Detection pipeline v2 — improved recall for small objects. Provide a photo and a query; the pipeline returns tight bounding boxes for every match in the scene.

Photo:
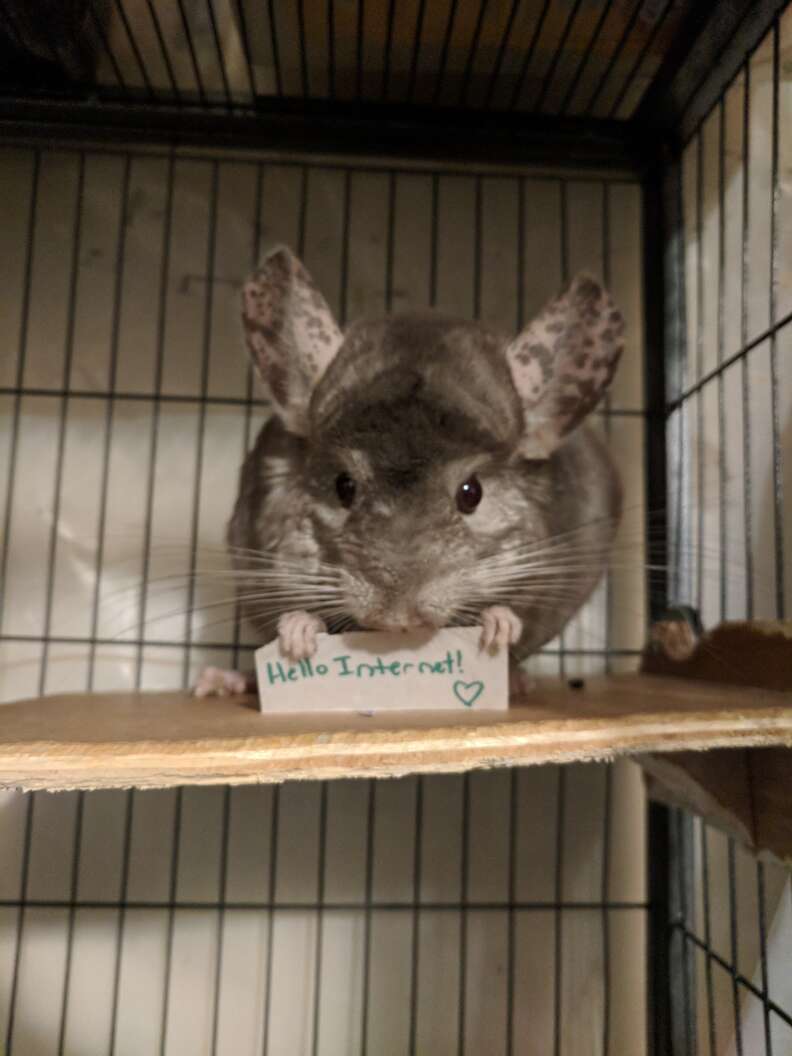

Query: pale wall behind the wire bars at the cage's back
[0,142,645,1056]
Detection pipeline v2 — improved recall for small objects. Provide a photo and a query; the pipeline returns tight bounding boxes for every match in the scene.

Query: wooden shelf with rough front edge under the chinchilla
[0,675,792,790]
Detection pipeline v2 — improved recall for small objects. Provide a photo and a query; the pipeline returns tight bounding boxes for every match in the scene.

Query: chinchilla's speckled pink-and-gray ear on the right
[506,275,624,458]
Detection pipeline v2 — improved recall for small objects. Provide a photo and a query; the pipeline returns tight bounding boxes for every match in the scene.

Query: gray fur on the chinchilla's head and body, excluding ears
[228,257,621,659]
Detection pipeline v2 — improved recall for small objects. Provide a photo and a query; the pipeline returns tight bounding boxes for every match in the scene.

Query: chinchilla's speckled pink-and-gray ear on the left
[242,246,342,435]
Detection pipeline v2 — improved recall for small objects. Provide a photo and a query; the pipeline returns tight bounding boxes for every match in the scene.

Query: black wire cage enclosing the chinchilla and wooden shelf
[0,0,792,1056]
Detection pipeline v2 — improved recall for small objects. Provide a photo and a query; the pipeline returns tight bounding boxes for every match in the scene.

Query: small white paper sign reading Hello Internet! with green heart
[256,627,509,713]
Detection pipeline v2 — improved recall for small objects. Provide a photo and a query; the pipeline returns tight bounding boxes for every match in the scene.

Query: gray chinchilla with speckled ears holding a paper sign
[197,242,624,693]
